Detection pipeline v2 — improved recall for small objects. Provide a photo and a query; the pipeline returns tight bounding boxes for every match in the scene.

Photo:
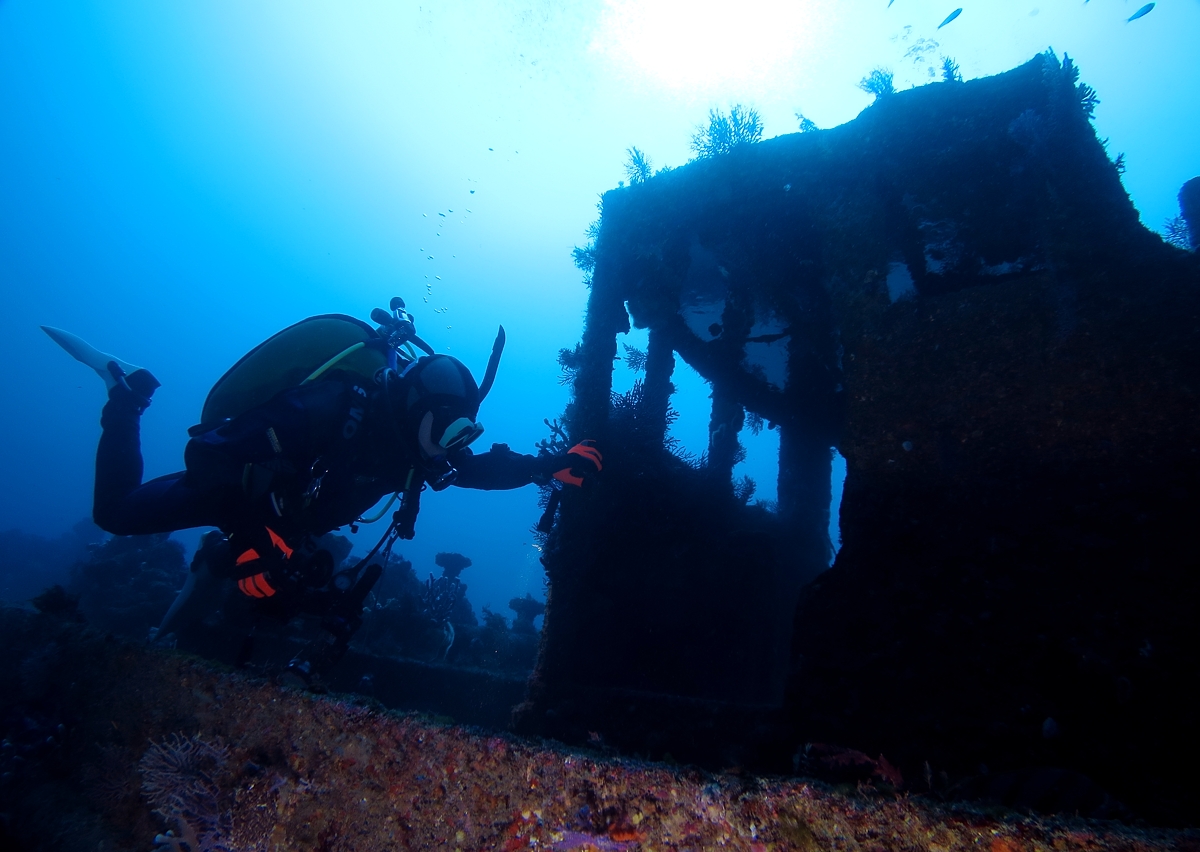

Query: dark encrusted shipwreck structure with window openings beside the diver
[525,54,1200,814]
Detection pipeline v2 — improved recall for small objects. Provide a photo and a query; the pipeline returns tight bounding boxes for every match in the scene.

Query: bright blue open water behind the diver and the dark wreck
[0,0,1200,612]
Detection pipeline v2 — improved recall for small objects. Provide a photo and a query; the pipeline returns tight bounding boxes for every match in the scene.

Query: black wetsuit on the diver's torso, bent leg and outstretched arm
[92,373,564,540]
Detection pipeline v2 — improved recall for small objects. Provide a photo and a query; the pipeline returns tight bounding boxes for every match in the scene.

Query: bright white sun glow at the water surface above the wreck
[590,0,816,96]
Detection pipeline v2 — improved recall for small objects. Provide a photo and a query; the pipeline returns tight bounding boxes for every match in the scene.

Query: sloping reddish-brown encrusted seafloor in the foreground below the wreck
[0,610,1200,852]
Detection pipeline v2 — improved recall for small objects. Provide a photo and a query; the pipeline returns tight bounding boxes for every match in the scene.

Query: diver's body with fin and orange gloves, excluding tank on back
[47,307,601,674]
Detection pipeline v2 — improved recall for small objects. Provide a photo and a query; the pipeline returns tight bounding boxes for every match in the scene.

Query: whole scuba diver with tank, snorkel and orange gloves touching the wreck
[42,296,602,684]
